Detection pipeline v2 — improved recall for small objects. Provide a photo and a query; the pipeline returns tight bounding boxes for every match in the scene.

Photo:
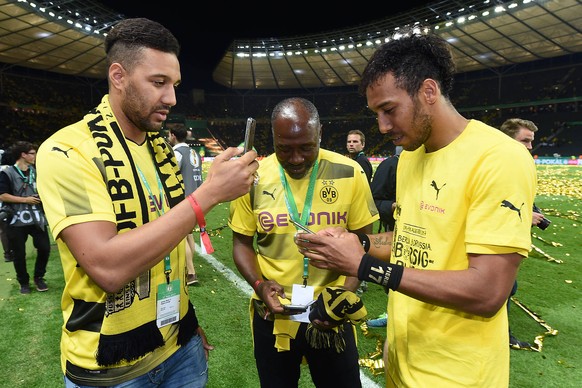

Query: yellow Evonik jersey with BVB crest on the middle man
[228,149,379,298]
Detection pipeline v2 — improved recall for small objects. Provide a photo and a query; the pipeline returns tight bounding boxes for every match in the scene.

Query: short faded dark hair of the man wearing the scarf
[105,18,180,68]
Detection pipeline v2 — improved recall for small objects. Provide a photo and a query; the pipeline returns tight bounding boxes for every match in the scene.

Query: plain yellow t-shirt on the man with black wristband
[386,121,536,388]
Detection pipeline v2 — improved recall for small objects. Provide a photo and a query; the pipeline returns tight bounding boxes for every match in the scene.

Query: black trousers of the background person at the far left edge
[8,225,51,285]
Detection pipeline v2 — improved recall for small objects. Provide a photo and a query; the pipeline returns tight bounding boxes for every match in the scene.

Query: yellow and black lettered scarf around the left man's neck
[84,95,198,366]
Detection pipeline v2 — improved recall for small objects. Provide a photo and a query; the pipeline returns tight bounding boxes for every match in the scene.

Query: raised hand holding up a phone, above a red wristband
[201,147,259,203]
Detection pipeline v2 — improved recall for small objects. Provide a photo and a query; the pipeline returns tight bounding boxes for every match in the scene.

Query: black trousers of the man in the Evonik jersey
[253,312,362,388]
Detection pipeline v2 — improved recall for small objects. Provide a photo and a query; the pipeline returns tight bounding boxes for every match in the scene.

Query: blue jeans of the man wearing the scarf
[64,335,208,388]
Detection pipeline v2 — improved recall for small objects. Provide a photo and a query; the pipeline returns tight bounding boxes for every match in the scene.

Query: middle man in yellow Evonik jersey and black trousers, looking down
[228,98,378,388]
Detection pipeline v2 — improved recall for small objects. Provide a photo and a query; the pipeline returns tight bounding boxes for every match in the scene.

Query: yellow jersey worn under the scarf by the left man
[37,121,189,385]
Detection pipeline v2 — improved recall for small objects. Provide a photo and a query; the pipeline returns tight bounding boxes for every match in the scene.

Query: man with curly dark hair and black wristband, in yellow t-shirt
[295,28,536,388]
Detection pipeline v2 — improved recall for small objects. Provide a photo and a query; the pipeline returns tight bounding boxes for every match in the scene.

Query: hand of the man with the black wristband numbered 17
[295,227,365,277]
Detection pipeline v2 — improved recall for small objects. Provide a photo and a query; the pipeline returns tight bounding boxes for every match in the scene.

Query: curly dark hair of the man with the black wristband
[359,31,456,99]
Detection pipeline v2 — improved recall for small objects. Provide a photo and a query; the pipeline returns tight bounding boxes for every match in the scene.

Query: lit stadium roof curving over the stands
[0,0,582,90]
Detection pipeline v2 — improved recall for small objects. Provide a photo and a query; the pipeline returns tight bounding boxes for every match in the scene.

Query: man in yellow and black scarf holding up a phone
[38,18,258,388]
